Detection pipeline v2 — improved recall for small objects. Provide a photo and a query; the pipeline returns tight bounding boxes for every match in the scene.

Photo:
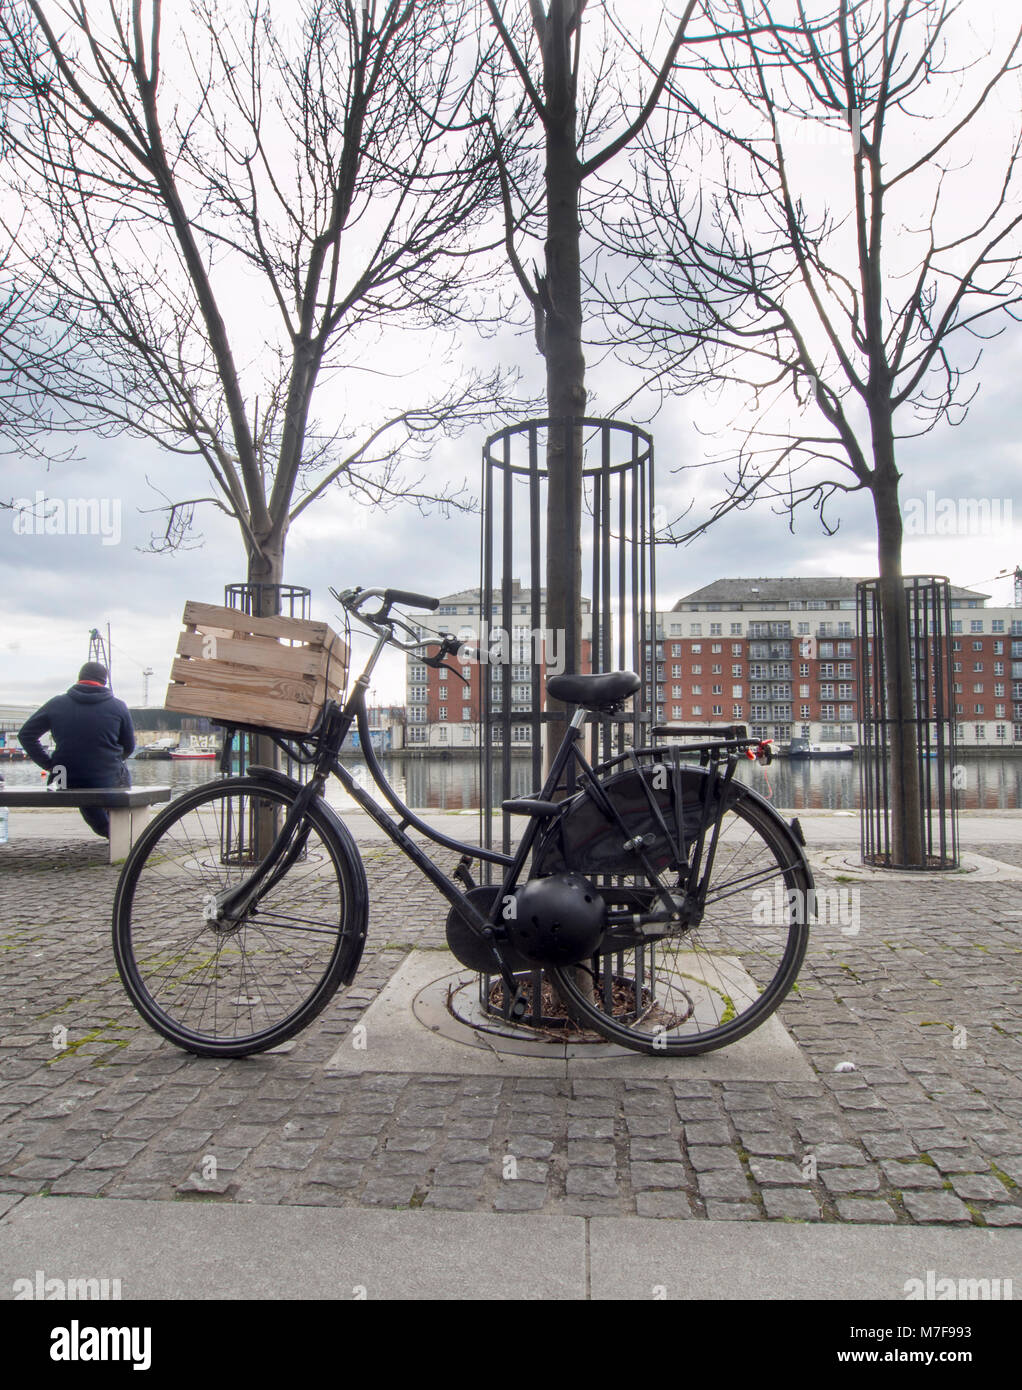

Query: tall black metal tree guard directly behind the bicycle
[480,417,656,1026]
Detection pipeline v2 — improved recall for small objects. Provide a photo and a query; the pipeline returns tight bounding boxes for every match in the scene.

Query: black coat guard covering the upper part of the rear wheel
[533,765,716,877]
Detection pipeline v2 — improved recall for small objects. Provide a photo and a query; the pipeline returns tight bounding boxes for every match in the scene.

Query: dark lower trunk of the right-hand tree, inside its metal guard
[873,453,925,867]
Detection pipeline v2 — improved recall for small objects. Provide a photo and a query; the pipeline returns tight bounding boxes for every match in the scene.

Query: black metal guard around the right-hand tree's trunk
[855,575,958,869]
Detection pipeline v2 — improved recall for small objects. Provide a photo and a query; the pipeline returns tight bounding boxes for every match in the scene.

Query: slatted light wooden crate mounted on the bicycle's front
[165,602,348,734]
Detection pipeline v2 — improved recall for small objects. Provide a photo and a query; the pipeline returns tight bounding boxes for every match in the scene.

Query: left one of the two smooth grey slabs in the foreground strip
[0,1197,585,1301]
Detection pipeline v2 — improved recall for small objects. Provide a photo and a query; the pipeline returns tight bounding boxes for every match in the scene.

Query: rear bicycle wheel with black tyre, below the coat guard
[551,769,812,1056]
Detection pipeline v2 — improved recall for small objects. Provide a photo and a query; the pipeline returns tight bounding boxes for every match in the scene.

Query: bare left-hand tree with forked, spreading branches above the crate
[0,0,520,608]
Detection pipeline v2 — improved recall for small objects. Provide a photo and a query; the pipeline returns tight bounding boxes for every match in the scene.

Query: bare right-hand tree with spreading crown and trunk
[605,0,1022,865]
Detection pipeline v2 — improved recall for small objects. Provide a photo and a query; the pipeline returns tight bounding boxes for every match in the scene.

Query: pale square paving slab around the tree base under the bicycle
[325,951,813,1081]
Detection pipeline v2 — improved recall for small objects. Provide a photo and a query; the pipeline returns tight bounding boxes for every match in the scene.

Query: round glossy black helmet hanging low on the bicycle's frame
[508,873,606,965]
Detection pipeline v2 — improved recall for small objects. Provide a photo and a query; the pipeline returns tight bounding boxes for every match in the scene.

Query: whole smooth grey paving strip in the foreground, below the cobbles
[0,1197,1022,1302]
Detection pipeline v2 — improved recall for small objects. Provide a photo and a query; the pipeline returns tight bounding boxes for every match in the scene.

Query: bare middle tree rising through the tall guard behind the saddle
[487,0,697,695]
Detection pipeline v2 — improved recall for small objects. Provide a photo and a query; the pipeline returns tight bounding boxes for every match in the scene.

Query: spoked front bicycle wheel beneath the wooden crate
[114,777,367,1056]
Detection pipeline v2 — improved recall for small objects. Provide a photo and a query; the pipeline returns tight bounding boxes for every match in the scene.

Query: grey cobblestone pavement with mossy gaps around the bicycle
[0,840,1022,1226]
